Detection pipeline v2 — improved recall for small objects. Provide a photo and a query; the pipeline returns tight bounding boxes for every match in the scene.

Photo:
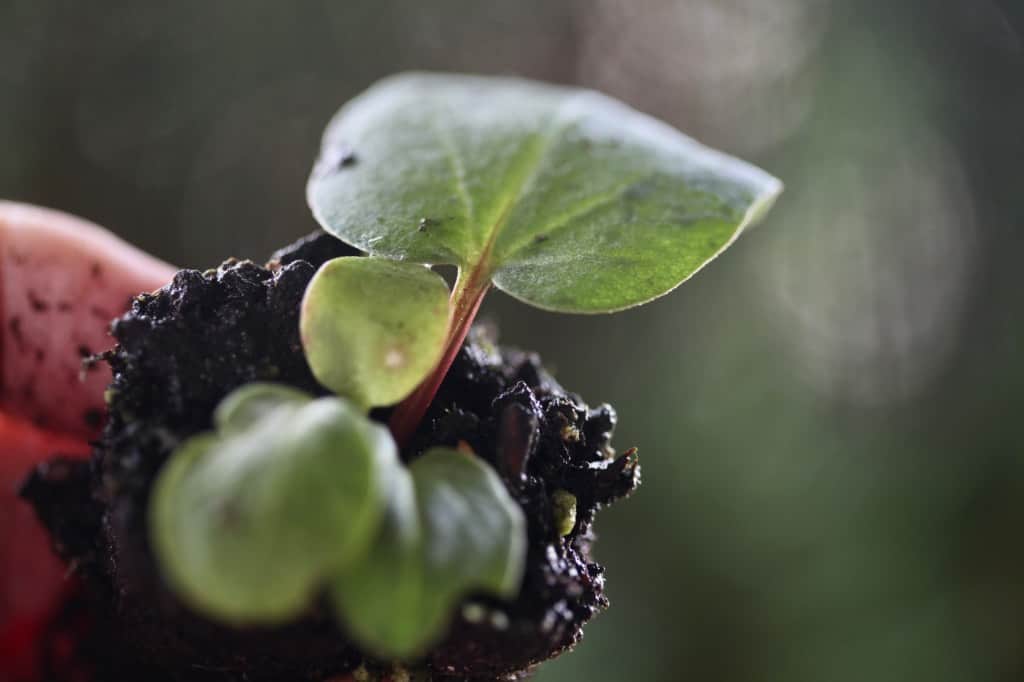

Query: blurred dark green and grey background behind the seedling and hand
[0,0,1024,682]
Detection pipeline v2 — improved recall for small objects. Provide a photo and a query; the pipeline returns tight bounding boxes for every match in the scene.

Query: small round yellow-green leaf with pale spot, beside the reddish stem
[300,253,450,408]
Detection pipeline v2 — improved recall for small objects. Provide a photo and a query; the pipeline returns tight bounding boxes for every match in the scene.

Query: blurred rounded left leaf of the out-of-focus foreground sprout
[150,384,401,624]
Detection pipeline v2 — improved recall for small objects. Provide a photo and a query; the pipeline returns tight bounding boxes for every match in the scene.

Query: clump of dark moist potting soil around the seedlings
[24,229,639,682]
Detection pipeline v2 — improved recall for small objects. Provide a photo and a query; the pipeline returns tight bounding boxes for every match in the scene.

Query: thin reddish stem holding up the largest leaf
[389,268,490,449]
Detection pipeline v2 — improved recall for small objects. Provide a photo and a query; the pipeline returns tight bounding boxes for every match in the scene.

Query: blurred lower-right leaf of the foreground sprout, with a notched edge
[333,447,526,658]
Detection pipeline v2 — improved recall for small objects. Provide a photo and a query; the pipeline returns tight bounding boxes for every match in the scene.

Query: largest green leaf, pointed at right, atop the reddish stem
[307,74,781,312]
